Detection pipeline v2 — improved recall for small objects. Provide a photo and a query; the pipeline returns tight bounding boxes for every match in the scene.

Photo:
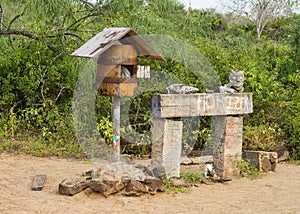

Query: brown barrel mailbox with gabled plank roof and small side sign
[72,28,165,97]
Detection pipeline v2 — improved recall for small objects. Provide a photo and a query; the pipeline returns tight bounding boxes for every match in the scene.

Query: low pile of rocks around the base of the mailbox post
[58,162,166,197]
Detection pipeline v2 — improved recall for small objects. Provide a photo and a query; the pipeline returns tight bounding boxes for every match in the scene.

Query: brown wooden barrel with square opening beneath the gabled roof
[97,45,138,96]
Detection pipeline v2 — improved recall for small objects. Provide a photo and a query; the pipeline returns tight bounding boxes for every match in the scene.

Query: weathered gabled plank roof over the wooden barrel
[71,28,165,61]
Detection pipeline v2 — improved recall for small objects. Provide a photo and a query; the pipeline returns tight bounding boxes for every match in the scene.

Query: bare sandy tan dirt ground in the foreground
[0,153,300,214]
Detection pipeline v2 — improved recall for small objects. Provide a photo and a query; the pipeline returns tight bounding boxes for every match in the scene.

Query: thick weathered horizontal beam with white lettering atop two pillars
[152,93,253,118]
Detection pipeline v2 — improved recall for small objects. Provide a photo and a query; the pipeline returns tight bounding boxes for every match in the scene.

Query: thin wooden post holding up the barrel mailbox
[112,95,121,162]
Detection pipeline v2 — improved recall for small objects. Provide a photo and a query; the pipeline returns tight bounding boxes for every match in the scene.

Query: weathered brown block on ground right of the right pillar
[243,151,278,172]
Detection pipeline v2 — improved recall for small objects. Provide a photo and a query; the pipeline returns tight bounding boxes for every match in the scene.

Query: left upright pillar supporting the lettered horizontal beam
[151,118,183,178]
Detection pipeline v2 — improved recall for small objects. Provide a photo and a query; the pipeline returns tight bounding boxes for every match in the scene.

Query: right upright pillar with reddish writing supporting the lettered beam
[214,116,243,178]
